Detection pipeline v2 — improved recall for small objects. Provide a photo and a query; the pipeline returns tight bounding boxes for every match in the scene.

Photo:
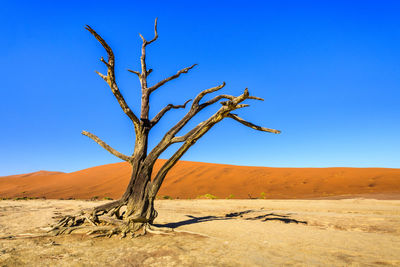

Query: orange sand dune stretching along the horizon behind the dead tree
[0,160,400,199]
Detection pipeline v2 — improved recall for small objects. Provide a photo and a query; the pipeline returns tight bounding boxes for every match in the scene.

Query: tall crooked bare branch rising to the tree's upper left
[85,25,140,132]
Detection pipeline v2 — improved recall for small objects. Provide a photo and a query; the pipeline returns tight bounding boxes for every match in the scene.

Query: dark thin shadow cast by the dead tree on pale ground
[155,210,307,228]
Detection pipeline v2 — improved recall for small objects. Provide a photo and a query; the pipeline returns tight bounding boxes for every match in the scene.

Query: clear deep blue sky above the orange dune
[0,0,400,175]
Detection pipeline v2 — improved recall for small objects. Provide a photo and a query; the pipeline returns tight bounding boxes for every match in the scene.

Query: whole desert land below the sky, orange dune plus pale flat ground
[0,160,400,266]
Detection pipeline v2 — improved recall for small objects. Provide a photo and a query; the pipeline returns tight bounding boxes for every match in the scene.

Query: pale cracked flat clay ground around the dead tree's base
[0,199,400,266]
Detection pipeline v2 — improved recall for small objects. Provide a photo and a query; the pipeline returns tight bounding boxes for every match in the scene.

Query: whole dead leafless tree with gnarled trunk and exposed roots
[52,19,280,239]
